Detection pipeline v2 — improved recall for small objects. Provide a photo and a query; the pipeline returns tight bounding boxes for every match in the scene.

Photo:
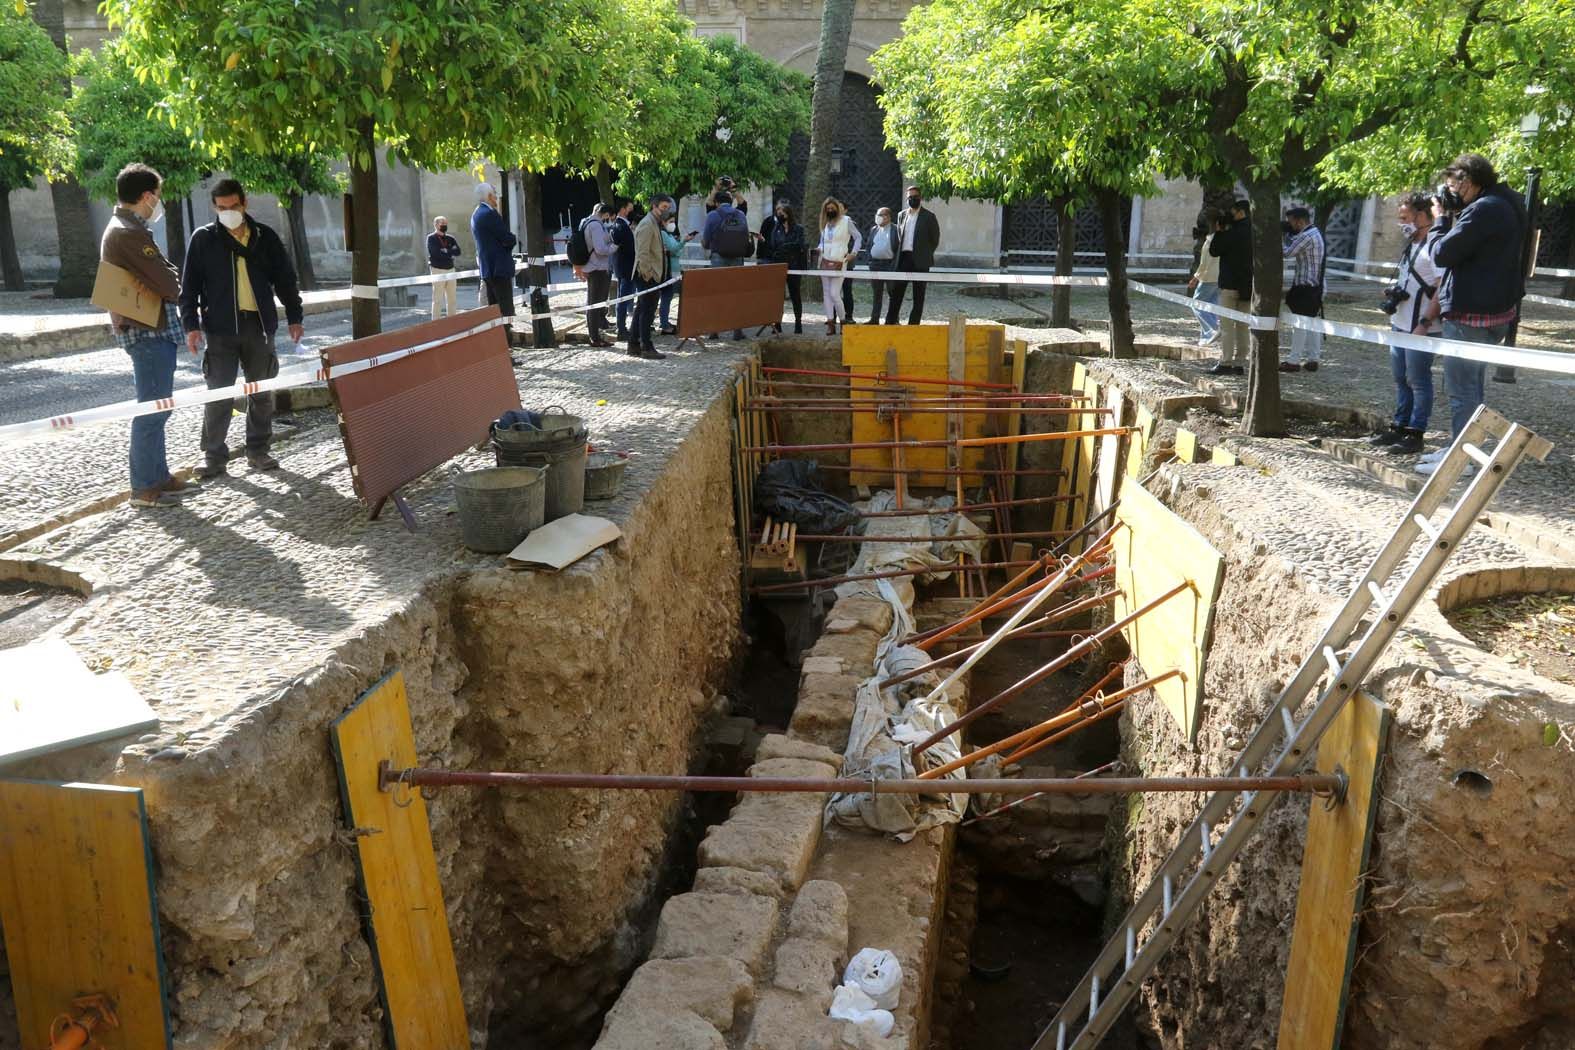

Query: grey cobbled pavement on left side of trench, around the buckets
[8,342,742,732]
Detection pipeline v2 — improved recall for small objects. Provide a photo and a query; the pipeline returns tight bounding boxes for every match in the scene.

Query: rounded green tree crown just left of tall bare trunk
[617,36,810,198]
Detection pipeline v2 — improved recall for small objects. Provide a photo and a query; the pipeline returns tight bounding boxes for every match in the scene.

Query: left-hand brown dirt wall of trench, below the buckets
[0,390,739,1050]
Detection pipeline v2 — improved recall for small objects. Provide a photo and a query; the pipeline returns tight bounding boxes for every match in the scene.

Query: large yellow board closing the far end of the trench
[843,324,1005,488]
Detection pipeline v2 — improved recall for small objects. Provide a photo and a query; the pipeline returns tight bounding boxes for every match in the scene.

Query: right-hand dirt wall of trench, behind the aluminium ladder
[1107,485,1575,1050]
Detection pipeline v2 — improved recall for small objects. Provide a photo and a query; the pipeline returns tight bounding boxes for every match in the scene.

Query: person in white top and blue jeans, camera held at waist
[1369,194,1440,455]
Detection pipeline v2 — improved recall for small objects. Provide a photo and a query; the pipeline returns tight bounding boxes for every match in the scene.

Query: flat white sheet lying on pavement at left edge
[0,638,159,765]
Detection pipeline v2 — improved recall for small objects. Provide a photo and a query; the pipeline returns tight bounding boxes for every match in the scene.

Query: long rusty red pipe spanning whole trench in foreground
[378,763,1345,795]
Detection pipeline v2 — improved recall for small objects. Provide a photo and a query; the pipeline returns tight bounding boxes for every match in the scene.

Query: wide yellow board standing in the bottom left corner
[0,781,170,1050]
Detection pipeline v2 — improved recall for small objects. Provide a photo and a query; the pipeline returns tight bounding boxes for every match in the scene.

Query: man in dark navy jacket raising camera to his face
[1418,153,1526,459]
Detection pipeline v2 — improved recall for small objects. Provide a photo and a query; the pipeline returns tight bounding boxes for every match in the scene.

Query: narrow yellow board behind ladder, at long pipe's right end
[1279,693,1389,1050]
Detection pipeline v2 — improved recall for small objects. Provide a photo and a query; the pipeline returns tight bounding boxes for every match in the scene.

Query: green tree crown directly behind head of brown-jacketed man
[71,41,213,200]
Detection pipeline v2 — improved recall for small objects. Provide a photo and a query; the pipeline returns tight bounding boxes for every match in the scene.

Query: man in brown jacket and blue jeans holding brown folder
[99,164,186,507]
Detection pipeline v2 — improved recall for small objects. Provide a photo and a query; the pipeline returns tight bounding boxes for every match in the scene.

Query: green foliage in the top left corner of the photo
[0,6,71,181]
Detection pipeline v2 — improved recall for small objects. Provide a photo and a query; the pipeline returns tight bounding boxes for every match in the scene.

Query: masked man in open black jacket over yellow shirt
[181,178,306,479]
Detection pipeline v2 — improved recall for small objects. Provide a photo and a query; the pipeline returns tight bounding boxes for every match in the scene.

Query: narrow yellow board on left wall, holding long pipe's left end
[332,671,471,1050]
